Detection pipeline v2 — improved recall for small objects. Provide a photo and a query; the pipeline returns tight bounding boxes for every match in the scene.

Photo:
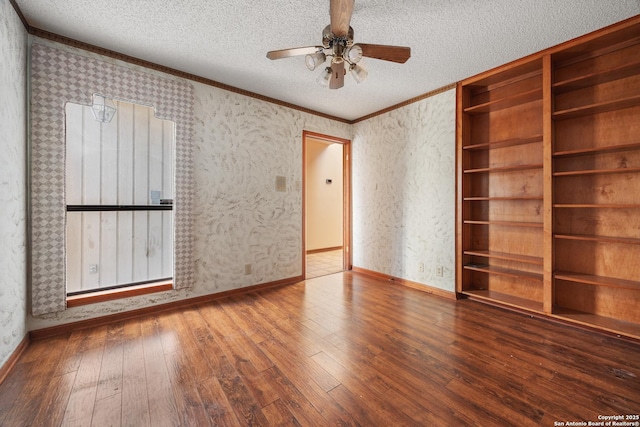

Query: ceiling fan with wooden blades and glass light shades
[267,0,411,89]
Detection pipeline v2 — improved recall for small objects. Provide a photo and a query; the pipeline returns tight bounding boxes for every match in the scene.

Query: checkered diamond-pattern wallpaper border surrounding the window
[30,43,195,316]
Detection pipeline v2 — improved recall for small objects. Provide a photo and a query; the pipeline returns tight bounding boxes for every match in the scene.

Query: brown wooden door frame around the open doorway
[302,130,353,279]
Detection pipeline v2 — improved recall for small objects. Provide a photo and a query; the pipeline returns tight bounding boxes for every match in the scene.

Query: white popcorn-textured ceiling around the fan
[16,0,640,120]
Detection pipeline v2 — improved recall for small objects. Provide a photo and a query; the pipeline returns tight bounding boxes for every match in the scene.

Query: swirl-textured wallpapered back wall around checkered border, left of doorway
[29,40,351,330]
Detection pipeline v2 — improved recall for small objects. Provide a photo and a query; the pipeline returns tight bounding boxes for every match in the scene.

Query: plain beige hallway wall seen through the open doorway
[305,138,343,251]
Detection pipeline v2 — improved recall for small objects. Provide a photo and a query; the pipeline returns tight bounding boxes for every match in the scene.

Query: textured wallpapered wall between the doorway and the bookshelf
[352,89,455,292]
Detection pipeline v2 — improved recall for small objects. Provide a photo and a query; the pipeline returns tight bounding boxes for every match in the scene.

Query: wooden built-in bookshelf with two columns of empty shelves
[456,16,640,339]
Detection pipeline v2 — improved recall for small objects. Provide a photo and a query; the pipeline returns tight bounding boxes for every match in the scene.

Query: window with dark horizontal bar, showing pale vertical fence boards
[65,101,175,295]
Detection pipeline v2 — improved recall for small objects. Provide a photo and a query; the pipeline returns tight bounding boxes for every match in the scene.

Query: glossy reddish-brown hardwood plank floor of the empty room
[0,273,640,427]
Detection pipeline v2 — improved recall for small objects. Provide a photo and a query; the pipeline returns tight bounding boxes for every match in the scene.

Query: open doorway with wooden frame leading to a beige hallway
[302,131,351,279]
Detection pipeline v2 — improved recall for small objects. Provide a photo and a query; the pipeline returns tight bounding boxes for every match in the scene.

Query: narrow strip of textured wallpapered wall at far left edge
[0,0,27,366]
